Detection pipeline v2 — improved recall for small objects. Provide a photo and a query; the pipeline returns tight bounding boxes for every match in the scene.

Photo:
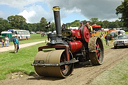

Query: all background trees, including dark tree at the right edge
[0,0,128,33]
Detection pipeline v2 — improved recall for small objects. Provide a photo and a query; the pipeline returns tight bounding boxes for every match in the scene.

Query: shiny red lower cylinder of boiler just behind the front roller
[69,41,83,53]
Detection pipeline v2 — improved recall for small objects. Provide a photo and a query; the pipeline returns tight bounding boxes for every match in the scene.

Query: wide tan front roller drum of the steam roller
[34,50,73,78]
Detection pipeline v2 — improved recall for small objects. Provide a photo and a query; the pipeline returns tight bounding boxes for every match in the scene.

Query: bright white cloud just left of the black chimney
[19,5,53,23]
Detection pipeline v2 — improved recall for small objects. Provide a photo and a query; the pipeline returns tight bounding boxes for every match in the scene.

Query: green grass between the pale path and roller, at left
[0,43,45,80]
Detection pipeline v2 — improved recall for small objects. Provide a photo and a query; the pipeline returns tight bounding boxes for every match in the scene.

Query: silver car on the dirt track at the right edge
[114,35,128,49]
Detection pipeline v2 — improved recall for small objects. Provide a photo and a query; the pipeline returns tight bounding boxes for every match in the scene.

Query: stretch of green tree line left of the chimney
[0,15,53,32]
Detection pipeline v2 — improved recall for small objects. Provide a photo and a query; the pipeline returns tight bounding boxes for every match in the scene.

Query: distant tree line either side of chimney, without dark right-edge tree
[0,15,123,32]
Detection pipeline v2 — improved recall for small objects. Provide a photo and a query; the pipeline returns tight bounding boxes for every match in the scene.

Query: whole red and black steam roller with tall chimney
[32,6,104,78]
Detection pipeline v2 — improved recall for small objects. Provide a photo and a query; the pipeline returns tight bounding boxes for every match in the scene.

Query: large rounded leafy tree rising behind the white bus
[8,15,26,29]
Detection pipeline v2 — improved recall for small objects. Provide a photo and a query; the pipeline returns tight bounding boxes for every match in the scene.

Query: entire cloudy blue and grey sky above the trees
[0,0,123,24]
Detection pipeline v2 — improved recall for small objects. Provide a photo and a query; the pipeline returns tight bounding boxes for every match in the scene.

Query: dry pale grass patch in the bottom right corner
[92,58,128,85]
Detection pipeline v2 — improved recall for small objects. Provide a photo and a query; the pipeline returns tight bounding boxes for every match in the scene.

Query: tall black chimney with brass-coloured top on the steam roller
[53,6,62,37]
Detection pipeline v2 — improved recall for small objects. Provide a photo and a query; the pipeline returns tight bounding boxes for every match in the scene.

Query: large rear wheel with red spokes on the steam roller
[88,37,104,65]
